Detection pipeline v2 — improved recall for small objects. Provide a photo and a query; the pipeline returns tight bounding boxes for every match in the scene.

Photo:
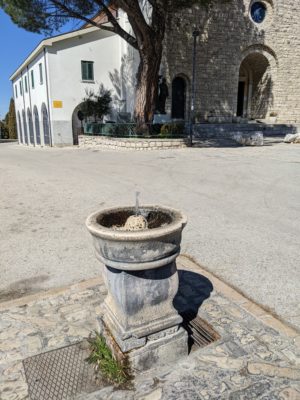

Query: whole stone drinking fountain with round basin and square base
[86,206,188,371]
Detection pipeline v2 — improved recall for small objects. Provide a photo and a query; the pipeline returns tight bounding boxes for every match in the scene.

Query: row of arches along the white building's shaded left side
[17,103,51,146]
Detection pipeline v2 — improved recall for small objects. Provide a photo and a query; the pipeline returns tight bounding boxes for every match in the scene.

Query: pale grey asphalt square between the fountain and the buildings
[0,143,300,327]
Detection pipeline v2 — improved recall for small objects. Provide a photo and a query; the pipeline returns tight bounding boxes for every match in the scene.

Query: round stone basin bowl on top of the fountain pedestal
[86,206,187,271]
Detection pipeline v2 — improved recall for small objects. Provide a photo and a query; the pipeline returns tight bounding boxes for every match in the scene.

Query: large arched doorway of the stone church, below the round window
[236,52,273,119]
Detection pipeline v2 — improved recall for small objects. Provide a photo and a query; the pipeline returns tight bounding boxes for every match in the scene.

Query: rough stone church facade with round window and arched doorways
[162,0,300,124]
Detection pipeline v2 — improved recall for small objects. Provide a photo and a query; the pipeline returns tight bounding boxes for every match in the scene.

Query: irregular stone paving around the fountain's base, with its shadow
[0,257,300,400]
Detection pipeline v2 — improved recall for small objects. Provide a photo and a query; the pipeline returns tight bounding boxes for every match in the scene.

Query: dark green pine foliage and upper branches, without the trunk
[0,0,211,39]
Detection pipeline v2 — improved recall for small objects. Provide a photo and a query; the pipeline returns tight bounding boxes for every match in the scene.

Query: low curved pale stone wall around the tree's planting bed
[79,135,188,150]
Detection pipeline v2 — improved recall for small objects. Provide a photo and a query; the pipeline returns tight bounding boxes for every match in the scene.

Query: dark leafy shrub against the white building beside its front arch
[80,85,112,121]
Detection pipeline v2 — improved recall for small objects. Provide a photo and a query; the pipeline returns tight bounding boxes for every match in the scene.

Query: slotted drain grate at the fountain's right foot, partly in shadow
[182,312,220,351]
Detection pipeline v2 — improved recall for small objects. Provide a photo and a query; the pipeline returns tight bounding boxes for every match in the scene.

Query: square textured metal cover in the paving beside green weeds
[23,341,104,400]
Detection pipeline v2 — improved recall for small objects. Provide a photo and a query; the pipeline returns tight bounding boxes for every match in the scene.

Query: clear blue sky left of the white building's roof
[0,9,79,119]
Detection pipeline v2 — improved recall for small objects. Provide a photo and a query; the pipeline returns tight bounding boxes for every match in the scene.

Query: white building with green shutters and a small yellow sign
[10,19,135,146]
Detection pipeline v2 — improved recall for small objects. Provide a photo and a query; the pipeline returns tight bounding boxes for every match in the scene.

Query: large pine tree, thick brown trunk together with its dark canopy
[0,0,216,123]
